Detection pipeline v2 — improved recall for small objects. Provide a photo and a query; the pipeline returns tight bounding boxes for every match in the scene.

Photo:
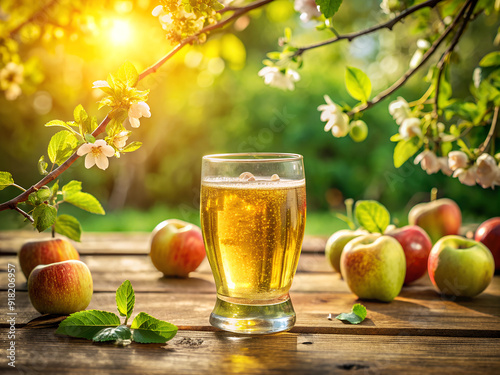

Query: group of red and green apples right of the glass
[325,199,500,302]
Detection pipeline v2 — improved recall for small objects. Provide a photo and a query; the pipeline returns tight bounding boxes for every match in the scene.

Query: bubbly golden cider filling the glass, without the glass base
[201,177,306,301]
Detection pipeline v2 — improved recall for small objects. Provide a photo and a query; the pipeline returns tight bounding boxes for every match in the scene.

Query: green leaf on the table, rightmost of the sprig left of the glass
[131,312,177,344]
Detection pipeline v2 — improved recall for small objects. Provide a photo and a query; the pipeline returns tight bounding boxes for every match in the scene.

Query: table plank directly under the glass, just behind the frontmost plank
[0,290,500,337]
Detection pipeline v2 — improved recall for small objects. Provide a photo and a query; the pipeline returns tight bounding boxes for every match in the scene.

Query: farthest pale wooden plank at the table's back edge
[0,230,326,255]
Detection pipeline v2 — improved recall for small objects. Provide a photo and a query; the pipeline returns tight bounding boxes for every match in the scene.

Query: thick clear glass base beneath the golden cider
[210,295,295,334]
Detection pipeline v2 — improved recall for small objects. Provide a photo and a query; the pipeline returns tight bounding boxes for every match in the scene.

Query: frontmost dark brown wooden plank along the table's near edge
[0,328,500,375]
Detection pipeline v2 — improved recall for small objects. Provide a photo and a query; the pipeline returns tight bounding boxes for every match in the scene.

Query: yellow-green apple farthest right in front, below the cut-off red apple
[427,236,495,297]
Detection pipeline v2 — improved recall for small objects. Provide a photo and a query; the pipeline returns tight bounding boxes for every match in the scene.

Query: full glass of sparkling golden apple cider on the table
[200,153,306,334]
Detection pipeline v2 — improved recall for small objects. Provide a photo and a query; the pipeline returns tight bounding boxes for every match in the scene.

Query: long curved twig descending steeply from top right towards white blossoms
[347,0,477,116]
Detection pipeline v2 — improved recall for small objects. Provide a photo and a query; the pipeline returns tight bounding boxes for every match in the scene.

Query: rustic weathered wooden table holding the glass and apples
[0,231,500,374]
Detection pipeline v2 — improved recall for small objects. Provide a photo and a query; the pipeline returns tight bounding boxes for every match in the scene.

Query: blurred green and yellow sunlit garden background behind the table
[0,0,500,235]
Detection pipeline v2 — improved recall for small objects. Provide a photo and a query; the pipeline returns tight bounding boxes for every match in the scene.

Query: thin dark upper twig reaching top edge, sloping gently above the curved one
[292,0,443,57]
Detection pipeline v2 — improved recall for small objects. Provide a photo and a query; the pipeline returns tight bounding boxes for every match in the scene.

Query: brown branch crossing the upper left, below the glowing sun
[0,0,273,211]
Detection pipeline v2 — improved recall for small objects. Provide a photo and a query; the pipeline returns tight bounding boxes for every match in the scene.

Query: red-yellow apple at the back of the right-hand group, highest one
[408,198,462,243]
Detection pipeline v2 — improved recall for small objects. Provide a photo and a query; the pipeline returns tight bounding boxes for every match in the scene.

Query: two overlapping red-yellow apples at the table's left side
[19,238,93,315]
